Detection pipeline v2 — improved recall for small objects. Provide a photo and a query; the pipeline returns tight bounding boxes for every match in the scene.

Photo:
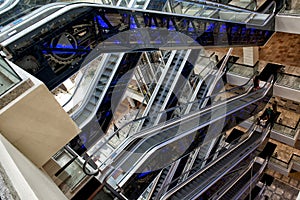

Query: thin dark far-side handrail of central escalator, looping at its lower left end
[83,72,254,175]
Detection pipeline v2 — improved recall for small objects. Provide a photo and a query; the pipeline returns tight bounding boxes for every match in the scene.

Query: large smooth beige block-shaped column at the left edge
[0,84,80,167]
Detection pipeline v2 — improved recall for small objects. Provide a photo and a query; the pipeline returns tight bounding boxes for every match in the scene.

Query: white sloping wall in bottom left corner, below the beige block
[0,134,67,200]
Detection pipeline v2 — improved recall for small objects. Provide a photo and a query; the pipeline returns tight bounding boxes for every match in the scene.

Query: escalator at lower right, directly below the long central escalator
[162,126,268,199]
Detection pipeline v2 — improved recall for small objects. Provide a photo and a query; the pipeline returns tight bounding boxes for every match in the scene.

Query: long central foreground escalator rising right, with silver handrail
[98,74,272,199]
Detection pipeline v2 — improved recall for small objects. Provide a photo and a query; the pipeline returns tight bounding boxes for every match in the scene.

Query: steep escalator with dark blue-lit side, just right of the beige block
[69,52,142,155]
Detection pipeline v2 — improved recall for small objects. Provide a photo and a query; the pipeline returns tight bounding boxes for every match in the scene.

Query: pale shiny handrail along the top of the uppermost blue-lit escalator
[2,2,274,46]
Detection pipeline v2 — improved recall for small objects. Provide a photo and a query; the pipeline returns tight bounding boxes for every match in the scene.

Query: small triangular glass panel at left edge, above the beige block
[0,56,21,94]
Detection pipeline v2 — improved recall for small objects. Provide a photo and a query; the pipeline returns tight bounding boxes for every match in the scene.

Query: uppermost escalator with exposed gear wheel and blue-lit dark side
[1,3,274,89]
